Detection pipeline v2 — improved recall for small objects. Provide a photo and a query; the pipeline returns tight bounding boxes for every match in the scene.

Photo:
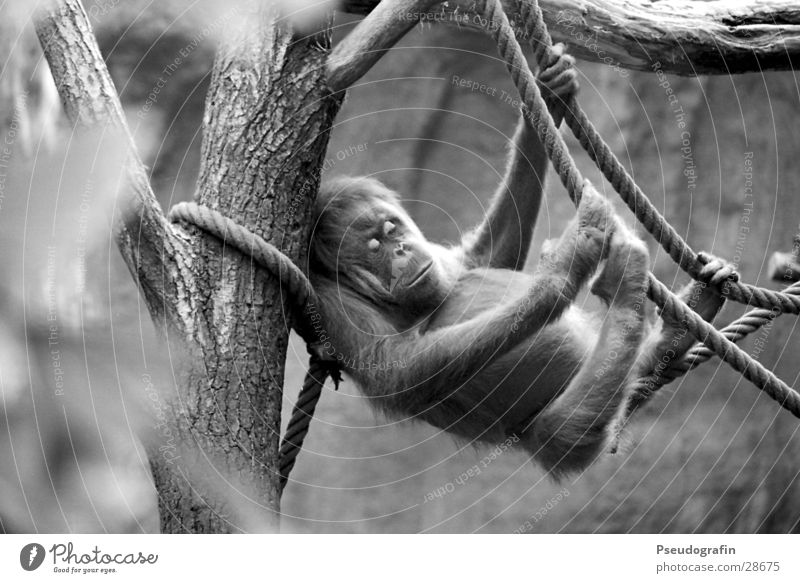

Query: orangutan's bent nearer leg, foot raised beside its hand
[521,228,649,477]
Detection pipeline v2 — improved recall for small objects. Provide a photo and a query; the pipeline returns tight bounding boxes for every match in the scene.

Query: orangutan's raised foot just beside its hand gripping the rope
[591,221,650,307]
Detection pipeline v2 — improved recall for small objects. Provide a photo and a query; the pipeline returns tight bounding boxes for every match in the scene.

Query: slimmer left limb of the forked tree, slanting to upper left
[34,0,175,325]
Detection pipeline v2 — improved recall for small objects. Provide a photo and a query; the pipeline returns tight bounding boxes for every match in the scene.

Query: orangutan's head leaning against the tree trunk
[311,178,448,320]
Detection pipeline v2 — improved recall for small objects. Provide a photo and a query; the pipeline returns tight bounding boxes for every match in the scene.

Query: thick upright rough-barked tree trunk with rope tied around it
[148,7,338,532]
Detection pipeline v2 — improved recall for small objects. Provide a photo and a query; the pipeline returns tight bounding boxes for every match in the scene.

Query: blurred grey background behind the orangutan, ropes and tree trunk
[0,0,800,533]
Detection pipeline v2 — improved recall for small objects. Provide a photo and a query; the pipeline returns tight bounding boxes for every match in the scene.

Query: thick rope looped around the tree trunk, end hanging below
[169,202,340,494]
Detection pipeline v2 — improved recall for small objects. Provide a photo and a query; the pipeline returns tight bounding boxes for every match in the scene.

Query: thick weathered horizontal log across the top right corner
[343,0,800,76]
